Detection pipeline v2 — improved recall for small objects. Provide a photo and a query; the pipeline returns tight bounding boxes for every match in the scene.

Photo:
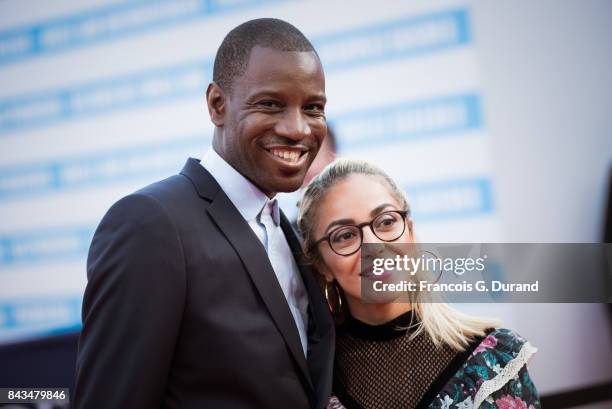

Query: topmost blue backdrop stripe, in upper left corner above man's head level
[0,0,279,64]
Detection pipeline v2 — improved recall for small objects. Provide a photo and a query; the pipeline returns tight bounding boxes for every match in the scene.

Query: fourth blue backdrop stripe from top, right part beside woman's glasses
[0,177,494,268]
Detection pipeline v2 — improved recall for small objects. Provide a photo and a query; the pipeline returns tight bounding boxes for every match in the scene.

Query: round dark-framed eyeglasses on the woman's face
[313,210,409,256]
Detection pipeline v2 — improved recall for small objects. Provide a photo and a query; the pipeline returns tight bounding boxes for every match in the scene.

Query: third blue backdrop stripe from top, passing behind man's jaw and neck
[0,94,482,202]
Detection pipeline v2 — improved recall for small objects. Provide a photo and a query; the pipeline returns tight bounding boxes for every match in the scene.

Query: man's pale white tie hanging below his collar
[260,199,308,355]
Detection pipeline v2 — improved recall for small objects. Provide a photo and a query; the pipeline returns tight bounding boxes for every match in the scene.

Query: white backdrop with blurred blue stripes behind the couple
[0,0,502,342]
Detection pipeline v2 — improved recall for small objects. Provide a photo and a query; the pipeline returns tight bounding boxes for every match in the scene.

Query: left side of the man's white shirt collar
[200,147,268,221]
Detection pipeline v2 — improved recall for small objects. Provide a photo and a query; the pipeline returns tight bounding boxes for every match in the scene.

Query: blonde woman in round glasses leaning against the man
[298,159,540,409]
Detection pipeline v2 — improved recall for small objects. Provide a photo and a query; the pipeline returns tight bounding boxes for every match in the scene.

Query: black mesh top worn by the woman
[334,312,480,409]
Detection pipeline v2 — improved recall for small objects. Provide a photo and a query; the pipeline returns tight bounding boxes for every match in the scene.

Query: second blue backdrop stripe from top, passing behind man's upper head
[0,10,470,134]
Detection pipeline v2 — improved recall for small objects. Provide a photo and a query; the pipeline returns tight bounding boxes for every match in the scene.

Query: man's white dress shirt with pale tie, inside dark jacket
[201,148,308,355]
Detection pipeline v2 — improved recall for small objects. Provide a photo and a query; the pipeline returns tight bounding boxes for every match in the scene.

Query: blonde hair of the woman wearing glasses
[298,159,500,351]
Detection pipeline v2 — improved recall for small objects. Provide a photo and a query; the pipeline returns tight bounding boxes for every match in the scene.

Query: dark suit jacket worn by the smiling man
[73,159,334,409]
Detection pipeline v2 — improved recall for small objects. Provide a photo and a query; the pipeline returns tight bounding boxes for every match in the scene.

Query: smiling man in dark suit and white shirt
[73,19,334,409]
